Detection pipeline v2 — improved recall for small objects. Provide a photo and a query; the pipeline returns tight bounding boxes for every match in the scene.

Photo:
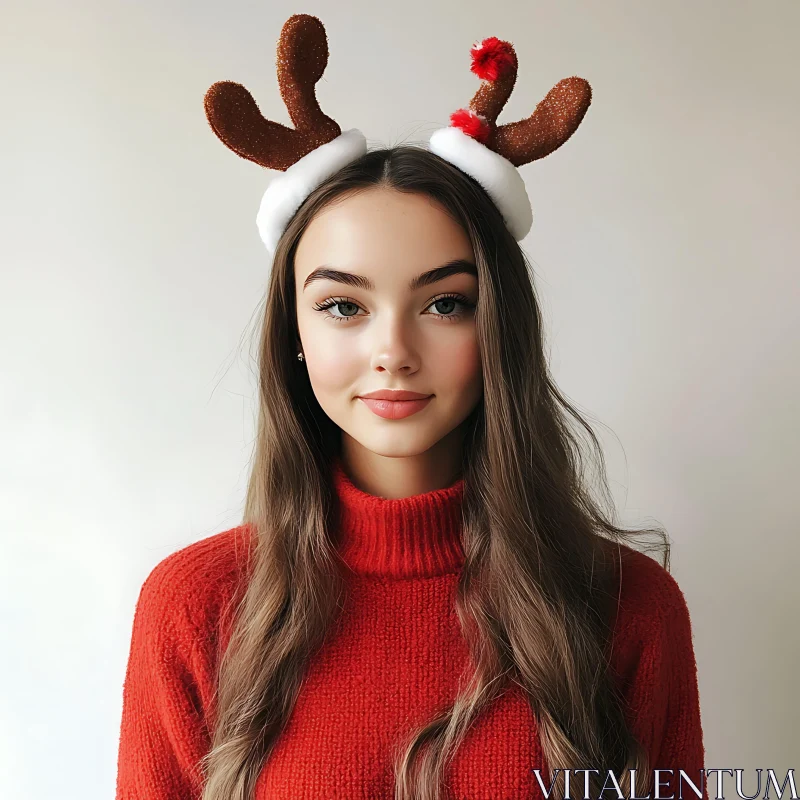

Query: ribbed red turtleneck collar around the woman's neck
[331,457,464,578]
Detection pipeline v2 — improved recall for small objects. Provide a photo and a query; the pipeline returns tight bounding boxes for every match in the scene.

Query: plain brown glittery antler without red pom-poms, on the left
[203,14,342,171]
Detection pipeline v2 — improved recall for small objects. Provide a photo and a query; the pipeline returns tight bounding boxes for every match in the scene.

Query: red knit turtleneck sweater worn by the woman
[116,462,707,800]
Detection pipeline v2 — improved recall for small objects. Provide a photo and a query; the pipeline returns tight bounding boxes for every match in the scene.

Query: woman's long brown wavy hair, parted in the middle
[197,145,669,800]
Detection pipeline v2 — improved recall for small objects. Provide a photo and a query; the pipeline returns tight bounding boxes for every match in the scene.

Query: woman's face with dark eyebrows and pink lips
[294,188,483,457]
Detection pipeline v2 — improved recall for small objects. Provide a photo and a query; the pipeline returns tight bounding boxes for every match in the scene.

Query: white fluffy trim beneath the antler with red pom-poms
[429,126,533,242]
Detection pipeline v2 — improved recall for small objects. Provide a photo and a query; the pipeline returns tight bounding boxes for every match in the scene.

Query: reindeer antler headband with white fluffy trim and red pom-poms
[204,14,592,253]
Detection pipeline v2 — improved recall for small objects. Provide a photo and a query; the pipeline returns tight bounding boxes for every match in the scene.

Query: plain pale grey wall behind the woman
[0,0,800,800]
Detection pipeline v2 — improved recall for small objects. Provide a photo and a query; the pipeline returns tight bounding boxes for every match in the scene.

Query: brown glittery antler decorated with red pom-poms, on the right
[456,37,592,167]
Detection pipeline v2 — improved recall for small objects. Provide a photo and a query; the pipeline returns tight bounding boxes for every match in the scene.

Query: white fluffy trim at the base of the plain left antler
[256,128,367,253]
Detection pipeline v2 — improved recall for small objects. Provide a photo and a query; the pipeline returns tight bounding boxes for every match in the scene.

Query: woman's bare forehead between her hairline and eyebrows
[295,187,474,283]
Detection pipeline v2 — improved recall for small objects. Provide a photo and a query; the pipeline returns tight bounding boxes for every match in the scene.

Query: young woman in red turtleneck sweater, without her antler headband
[117,12,705,800]
